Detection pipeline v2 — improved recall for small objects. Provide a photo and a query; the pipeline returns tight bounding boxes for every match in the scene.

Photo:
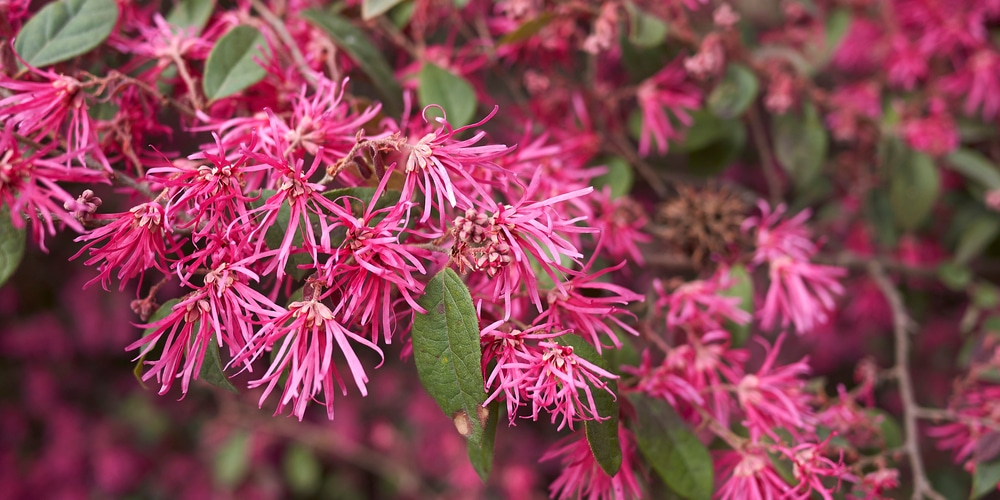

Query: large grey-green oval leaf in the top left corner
[14,0,118,67]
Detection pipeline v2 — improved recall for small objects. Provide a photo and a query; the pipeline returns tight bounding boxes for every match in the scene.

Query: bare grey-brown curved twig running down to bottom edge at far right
[868,261,944,500]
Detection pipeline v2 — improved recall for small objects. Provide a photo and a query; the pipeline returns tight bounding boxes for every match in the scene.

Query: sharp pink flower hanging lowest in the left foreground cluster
[240,292,384,420]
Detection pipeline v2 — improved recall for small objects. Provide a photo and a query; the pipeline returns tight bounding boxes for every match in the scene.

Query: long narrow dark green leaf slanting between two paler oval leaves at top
[302,10,403,116]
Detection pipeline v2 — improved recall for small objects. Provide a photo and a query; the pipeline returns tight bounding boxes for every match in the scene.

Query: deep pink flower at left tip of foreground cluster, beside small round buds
[71,203,180,290]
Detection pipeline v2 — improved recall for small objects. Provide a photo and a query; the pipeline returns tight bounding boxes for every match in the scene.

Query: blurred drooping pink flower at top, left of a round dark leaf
[636,58,701,156]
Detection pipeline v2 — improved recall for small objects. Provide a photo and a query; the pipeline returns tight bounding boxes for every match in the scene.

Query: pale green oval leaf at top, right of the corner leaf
[201,26,267,100]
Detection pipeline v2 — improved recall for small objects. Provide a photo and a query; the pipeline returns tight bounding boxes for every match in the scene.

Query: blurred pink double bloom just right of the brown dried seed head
[743,201,846,334]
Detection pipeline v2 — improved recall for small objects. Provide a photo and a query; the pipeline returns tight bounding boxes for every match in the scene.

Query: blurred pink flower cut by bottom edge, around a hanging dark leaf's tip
[539,426,642,500]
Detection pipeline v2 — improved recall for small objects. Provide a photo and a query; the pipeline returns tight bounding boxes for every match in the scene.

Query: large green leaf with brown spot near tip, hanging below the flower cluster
[412,268,486,446]
